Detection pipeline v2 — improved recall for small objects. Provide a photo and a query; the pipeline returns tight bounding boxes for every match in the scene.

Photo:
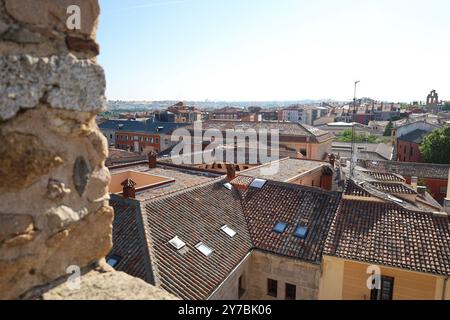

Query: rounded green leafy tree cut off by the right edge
[420,126,450,164]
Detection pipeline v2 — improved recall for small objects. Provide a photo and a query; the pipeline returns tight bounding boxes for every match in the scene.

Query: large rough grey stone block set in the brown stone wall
[0,54,106,120]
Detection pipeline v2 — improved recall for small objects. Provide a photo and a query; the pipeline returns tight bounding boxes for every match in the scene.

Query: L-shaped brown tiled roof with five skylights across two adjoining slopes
[111,177,340,299]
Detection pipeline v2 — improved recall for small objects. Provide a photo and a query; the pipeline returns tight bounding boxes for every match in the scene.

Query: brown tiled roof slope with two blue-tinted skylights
[242,181,341,263]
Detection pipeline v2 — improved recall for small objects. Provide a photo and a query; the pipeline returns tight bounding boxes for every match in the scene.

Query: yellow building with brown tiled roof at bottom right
[319,199,450,300]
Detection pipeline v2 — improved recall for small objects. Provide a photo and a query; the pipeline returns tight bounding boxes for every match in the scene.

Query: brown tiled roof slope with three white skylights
[143,182,252,299]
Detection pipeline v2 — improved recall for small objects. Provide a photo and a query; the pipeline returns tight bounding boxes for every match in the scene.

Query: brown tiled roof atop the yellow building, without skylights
[324,200,450,276]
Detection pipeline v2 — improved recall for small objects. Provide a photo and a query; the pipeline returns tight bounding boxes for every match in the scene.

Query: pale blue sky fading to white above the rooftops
[97,0,450,101]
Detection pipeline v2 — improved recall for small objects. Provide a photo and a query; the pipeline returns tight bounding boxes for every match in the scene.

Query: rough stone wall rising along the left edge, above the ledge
[0,0,176,299]
